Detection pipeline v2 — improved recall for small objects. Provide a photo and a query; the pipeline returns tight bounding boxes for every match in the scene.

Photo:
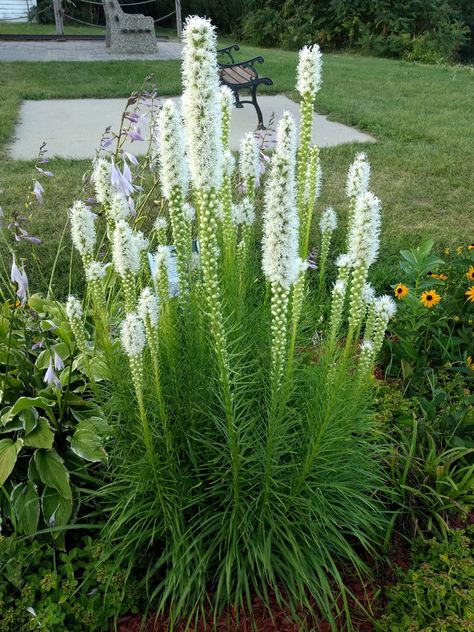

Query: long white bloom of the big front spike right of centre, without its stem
[262,126,301,289]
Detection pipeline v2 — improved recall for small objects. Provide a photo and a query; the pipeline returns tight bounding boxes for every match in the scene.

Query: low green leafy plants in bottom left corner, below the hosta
[0,536,140,632]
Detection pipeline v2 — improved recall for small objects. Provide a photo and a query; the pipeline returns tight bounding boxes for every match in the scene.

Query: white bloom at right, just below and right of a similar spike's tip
[348,191,380,268]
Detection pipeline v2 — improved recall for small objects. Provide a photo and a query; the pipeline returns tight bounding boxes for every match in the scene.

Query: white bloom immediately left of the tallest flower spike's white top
[157,99,189,199]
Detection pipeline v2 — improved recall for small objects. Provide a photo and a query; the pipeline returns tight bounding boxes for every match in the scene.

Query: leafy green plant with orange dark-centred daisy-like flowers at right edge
[387,241,474,392]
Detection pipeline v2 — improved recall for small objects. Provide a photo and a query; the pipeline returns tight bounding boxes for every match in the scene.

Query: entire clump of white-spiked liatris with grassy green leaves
[61,17,395,630]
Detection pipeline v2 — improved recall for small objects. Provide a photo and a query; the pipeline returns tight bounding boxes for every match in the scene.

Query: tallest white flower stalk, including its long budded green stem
[182,17,240,508]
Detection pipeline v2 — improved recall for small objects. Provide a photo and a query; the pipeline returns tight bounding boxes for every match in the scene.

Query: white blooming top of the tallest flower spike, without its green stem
[182,16,222,191]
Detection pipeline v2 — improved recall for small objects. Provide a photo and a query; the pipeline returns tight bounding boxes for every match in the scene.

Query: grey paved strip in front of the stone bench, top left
[0,40,183,62]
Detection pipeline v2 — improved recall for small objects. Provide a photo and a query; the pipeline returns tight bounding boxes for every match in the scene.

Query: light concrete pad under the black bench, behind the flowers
[8,95,375,160]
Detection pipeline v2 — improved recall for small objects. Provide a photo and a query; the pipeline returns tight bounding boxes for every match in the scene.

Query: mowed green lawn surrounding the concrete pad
[0,46,474,291]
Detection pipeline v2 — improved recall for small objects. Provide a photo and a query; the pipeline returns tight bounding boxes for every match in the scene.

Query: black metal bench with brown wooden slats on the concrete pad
[217,44,273,129]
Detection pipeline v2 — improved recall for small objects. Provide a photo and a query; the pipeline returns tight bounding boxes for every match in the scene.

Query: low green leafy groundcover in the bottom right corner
[376,526,474,632]
